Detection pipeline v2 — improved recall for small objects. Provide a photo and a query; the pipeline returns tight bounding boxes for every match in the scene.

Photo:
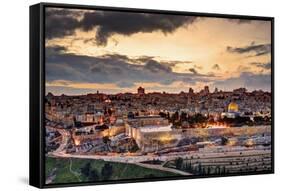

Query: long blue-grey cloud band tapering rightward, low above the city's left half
[46,47,214,87]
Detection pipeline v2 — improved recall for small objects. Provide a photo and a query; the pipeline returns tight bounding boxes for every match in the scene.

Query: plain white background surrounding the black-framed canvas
[0,0,276,191]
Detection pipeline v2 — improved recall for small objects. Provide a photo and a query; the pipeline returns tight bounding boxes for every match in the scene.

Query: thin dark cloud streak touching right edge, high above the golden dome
[226,43,271,56]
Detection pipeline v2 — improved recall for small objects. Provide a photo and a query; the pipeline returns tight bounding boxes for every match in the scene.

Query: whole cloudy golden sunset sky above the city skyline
[45,8,271,95]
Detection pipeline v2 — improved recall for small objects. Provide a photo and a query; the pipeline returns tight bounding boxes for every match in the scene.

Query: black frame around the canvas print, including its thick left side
[29,3,274,188]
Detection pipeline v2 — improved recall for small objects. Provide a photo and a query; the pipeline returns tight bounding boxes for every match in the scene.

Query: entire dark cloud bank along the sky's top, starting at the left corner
[46,9,196,46]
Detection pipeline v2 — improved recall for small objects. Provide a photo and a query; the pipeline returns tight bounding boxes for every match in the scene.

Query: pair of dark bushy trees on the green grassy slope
[80,162,113,181]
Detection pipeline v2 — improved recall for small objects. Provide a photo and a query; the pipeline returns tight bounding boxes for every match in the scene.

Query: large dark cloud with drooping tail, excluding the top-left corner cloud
[81,11,196,45]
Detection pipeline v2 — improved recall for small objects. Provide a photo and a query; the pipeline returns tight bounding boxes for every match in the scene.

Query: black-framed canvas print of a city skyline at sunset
[30,3,274,188]
